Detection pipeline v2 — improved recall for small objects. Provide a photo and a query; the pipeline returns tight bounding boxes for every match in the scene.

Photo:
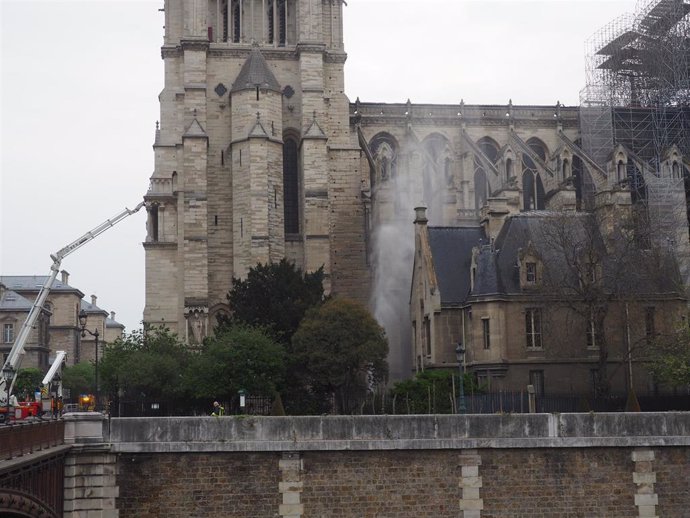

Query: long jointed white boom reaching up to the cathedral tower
[0,202,144,404]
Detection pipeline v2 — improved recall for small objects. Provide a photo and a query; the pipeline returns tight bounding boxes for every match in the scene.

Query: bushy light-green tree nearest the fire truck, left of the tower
[99,328,191,398]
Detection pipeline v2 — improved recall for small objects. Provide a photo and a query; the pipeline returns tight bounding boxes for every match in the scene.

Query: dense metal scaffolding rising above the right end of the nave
[580,0,690,167]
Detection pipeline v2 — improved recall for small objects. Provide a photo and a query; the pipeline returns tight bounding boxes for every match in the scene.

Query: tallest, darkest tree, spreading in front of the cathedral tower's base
[219,259,323,345]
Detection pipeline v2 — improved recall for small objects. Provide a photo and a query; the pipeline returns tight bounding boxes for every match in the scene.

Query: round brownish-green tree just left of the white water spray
[292,298,388,413]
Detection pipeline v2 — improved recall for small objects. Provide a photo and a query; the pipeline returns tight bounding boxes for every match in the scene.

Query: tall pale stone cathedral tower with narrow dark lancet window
[144,0,362,344]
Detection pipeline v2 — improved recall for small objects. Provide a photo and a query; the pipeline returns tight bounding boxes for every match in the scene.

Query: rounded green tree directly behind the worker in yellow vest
[185,325,285,401]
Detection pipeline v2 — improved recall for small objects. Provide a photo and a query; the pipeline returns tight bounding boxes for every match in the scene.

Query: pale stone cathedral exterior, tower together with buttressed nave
[144,0,690,386]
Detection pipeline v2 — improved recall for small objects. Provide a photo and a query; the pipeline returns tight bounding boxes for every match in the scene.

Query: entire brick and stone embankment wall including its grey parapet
[0,413,690,518]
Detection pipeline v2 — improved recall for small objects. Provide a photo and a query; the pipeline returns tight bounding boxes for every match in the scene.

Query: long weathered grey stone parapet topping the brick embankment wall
[103,412,690,453]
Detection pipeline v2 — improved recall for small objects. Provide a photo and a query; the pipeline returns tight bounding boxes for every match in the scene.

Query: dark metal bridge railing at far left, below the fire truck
[0,420,65,460]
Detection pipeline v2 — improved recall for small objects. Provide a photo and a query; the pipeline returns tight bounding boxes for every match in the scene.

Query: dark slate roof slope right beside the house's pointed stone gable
[428,227,486,305]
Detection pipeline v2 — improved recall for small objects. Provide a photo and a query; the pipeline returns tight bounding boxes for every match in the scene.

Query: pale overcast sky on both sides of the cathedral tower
[0,0,635,331]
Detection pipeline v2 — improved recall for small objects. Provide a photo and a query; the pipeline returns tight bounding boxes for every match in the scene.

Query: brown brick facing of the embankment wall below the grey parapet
[117,448,690,518]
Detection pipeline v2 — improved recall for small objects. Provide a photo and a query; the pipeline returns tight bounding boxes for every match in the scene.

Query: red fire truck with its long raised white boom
[0,202,144,422]
